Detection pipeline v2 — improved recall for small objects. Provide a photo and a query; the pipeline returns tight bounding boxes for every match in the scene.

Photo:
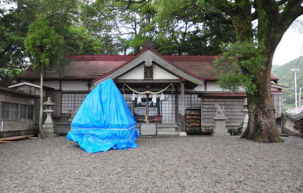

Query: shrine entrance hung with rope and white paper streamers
[119,83,179,135]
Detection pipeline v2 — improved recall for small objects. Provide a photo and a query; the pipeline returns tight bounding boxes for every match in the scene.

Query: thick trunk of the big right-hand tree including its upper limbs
[232,0,282,142]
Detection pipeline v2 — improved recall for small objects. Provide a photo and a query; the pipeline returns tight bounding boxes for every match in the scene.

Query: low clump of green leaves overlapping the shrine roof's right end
[215,42,265,94]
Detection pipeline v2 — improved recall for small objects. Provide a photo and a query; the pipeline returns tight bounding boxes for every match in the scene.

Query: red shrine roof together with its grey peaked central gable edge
[19,49,278,83]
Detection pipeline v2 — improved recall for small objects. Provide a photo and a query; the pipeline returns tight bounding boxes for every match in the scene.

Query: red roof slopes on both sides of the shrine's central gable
[20,50,278,80]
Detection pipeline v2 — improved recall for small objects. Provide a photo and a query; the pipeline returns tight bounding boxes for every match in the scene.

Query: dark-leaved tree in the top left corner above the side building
[0,0,37,81]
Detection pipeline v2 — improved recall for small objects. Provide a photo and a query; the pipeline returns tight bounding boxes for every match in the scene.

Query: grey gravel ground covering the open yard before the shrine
[0,136,303,193]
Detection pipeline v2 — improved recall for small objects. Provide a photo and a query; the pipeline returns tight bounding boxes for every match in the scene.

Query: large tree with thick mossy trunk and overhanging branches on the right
[160,0,303,142]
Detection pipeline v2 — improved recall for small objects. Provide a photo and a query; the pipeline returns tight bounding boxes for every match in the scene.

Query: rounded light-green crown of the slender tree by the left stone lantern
[25,17,64,68]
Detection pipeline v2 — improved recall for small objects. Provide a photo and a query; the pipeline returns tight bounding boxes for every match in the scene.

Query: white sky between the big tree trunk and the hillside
[273,16,303,65]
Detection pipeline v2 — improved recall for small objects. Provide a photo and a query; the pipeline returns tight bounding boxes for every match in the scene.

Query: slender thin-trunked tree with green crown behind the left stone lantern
[25,0,100,137]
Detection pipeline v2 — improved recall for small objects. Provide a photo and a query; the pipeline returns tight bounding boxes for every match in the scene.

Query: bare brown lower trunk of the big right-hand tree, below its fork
[242,52,282,143]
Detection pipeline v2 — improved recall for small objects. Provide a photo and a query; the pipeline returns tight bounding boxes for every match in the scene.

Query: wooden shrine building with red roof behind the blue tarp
[19,48,282,134]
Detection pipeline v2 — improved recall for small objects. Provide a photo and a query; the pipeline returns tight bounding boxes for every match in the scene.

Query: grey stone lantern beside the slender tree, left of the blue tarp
[42,97,55,137]
